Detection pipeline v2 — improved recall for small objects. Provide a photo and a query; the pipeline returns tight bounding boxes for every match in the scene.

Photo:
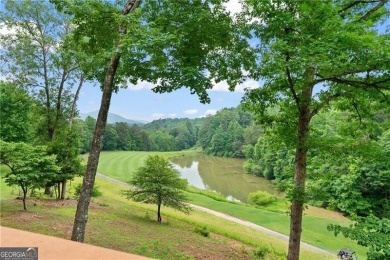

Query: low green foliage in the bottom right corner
[328,215,390,260]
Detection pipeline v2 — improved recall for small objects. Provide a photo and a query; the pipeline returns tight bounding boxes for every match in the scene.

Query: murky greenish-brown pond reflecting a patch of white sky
[171,155,277,202]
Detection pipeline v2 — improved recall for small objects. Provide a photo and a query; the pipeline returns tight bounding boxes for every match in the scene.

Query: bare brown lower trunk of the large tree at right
[287,88,312,260]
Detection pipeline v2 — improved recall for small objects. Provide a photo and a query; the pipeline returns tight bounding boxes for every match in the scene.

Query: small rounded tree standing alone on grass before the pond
[125,155,190,222]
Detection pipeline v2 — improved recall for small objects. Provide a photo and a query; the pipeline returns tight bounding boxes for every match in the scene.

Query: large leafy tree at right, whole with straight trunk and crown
[238,0,390,260]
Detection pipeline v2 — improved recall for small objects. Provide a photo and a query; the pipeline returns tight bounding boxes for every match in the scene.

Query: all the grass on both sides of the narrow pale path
[1,151,365,259]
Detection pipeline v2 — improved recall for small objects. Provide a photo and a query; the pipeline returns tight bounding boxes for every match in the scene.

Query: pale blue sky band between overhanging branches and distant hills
[77,81,258,121]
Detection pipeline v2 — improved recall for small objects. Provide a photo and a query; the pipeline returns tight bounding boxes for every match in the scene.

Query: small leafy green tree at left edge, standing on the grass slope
[0,140,59,210]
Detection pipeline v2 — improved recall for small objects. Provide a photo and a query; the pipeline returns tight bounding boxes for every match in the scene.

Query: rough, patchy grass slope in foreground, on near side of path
[0,162,333,259]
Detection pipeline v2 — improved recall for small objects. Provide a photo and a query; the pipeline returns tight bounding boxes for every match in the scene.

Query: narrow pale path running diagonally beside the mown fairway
[96,173,335,256]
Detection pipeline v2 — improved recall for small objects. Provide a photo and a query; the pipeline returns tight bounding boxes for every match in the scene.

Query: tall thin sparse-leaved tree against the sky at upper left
[0,0,84,196]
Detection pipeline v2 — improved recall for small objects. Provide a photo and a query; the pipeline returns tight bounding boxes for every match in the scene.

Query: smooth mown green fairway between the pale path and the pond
[98,150,367,259]
